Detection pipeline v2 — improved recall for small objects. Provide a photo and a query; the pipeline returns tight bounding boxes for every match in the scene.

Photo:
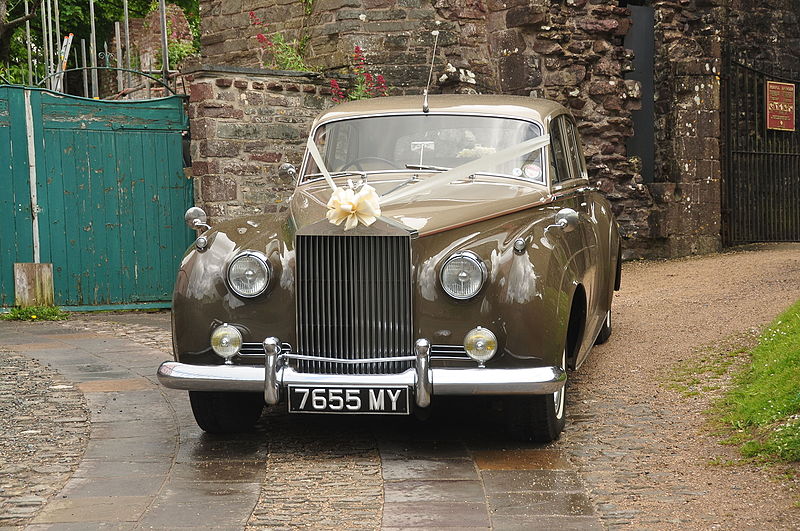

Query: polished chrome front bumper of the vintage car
[158,361,567,395]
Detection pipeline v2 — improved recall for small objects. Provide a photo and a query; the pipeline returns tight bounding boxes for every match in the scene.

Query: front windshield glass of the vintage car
[305,114,544,182]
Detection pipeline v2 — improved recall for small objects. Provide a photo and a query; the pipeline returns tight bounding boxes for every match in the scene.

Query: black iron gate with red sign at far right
[722,54,800,245]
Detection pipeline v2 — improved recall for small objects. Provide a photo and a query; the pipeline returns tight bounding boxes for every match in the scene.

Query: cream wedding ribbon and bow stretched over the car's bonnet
[306,135,550,230]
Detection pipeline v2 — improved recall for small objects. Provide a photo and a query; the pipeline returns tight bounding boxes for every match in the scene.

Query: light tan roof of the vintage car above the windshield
[314,94,567,126]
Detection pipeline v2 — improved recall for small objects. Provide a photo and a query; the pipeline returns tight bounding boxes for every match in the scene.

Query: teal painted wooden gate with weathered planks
[0,86,193,308]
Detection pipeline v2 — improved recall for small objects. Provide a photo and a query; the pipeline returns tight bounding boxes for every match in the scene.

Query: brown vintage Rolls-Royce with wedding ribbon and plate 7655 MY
[158,95,620,441]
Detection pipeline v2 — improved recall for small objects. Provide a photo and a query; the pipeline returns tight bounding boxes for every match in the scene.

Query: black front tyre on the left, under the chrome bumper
[189,391,264,433]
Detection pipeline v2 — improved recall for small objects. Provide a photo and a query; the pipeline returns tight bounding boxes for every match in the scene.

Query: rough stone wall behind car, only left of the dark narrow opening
[201,0,653,256]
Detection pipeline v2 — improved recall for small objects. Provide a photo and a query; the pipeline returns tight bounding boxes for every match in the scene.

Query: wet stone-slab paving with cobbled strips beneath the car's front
[0,313,603,530]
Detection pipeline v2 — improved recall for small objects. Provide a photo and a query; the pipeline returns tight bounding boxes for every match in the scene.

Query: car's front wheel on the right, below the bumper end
[508,347,567,443]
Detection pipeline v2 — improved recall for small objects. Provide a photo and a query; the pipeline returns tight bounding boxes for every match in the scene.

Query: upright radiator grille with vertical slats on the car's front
[296,235,414,374]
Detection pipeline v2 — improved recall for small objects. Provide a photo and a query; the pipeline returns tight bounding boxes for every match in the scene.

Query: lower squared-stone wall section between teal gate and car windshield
[187,66,333,221]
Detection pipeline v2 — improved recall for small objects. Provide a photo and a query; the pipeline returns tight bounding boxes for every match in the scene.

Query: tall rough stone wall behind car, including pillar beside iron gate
[191,0,800,258]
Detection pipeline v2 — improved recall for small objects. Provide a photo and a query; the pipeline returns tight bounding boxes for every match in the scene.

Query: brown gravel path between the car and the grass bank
[558,244,800,529]
